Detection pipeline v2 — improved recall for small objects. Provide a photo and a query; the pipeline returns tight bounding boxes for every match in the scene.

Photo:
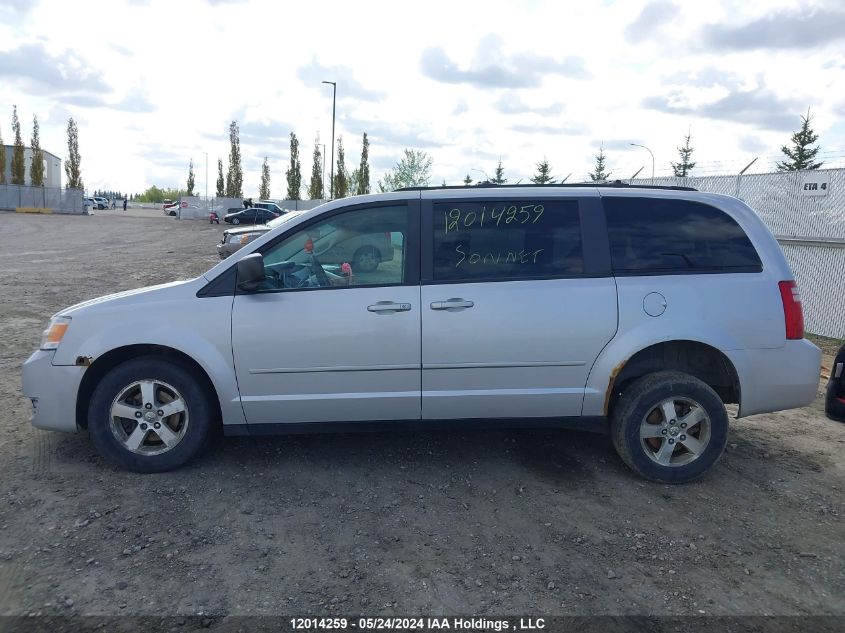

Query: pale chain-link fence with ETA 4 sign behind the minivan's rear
[629,169,845,339]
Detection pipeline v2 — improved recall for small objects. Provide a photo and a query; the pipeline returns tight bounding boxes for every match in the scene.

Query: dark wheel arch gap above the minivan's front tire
[76,344,223,429]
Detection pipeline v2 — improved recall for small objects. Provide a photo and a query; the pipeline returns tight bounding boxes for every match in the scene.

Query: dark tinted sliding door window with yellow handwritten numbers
[434,199,584,281]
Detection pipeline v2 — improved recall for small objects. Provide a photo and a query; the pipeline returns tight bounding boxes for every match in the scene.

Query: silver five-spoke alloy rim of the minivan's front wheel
[109,380,189,455]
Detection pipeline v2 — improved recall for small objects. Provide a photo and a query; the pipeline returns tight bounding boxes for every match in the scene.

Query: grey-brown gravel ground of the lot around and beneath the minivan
[0,212,845,616]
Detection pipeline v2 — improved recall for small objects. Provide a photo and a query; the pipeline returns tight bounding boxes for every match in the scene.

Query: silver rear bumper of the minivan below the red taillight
[725,339,822,418]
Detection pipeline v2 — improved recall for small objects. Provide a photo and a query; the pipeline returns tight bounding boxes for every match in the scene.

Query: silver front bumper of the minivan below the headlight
[21,350,86,433]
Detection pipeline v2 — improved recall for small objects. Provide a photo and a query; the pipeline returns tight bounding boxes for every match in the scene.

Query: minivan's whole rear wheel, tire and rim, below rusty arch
[610,371,728,483]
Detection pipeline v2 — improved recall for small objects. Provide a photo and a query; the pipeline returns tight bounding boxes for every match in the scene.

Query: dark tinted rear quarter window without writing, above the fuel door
[602,197,763,274]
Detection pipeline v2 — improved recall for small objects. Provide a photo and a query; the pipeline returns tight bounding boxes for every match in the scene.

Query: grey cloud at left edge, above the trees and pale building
[0,43,110,93]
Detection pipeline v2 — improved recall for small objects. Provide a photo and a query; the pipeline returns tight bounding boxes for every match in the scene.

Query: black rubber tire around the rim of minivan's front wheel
[88,356,218,473]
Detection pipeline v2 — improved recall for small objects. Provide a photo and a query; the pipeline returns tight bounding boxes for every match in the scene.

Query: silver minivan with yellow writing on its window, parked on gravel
[23,185,821,482]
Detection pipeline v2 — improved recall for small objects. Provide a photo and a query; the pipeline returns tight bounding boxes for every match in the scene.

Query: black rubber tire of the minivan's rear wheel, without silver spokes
[610,371,728,484]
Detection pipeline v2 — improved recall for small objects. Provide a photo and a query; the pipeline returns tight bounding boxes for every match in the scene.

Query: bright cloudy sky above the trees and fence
[0,0,845,198]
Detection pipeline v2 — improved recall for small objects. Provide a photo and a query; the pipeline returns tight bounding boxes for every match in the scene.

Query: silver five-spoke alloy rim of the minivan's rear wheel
[639,398,711,468]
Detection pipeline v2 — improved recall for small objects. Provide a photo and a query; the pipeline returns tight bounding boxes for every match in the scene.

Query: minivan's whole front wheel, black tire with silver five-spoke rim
[88,357,215,473]
